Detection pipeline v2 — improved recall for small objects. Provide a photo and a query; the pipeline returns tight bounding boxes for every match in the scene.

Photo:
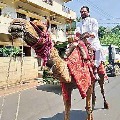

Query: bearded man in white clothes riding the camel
[76,6,104,79]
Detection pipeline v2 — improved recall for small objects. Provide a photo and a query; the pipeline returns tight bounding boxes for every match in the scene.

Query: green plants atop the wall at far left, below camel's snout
[0,46,21,57]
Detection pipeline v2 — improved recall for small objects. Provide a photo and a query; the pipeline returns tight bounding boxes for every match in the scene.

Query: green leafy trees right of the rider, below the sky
[98,25,120,47]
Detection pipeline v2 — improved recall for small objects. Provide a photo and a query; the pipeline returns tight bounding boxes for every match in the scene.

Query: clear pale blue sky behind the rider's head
[65,0,120,27]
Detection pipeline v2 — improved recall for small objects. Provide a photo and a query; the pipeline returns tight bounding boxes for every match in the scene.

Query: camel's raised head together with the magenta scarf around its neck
[9,19,52,65]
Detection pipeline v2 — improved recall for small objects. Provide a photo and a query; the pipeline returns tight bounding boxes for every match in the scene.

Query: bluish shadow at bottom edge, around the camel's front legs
[39,110,87,120]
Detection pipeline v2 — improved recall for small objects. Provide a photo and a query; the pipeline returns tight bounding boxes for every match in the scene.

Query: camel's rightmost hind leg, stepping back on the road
[98,75,109,109]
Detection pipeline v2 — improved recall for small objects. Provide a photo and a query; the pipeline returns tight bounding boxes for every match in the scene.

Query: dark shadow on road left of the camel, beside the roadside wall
[36,85,62,95]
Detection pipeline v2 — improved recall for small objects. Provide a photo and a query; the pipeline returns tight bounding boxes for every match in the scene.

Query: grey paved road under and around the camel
[0,77,120,120]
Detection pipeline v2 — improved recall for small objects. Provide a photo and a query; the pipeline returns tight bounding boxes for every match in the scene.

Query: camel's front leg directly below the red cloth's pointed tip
[86,85,93,120]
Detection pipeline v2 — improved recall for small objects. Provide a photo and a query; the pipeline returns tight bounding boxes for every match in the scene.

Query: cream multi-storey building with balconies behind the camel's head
[0,0,76,86]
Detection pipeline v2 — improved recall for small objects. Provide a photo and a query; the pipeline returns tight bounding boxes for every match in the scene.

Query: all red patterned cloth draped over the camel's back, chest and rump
[61,40,106,101]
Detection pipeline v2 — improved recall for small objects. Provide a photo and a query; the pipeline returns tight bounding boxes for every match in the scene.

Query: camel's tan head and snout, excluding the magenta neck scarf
[9,18,49,46]
